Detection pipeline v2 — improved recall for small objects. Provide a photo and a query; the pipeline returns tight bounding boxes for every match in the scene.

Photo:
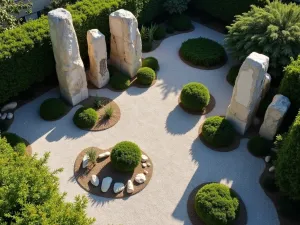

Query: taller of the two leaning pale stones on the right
[226,52,269,134]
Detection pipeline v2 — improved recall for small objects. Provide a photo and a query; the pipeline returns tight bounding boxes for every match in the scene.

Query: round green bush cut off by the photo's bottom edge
[195,183,239,225]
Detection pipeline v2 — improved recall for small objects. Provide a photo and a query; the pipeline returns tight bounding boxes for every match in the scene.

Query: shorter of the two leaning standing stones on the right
[259,95,291,140]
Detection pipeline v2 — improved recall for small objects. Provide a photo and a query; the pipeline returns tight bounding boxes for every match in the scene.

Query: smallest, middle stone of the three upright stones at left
[87,29,109,88]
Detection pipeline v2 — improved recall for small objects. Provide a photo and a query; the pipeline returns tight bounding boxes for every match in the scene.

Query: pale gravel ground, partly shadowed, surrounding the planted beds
[10,23,279,225]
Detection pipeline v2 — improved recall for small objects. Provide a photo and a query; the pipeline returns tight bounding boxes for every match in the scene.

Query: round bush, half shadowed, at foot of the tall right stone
[202,116,236,147]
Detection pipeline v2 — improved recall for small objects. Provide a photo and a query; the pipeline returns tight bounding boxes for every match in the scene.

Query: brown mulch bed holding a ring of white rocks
[74,147,153,198]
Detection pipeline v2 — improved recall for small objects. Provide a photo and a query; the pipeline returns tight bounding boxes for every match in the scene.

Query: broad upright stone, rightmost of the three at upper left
[109,9,142,77]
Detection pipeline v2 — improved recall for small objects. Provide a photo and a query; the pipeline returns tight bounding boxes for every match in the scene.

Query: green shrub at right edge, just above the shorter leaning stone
[279,56,300,109]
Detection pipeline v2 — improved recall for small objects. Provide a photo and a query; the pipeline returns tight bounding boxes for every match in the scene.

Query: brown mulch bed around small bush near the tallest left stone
[78,96,121,131]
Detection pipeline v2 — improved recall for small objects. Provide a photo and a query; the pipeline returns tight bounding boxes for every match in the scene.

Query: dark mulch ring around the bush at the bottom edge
[187,182,248,225]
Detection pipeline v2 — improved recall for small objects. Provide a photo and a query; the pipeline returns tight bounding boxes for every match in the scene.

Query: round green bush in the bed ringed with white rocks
[110,141,142,172]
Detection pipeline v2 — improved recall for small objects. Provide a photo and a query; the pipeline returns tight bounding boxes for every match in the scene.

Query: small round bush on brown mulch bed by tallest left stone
[73,107,98,129]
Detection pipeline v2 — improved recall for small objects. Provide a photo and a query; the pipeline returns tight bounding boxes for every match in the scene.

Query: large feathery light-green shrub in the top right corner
[225,1,300,75]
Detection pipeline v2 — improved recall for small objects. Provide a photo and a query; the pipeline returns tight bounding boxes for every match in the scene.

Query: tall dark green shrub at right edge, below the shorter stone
[275,113,300,200]
